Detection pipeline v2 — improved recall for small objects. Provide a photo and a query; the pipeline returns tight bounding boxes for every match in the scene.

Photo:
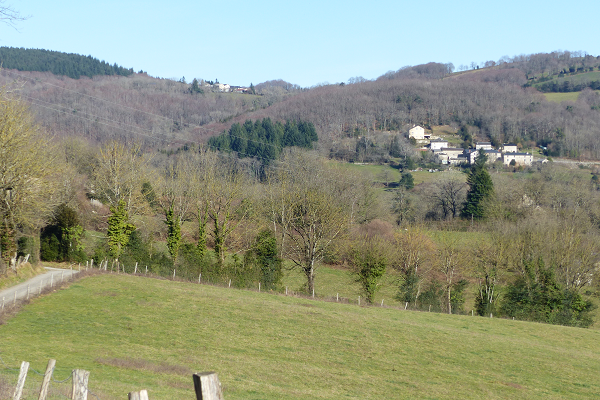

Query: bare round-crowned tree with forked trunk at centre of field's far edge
[268,152,355,293]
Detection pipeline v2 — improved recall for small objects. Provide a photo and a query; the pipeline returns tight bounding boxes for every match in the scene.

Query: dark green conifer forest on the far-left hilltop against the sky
[0,47,133,79]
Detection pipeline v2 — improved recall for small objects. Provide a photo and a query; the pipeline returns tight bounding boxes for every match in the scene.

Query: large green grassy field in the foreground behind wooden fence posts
[0,275,600,400]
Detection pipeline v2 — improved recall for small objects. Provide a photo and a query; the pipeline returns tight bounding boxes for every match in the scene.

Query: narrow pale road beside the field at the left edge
[0,267,77,312]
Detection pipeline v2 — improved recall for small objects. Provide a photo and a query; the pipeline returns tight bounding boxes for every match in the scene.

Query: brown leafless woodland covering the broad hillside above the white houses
[1,52,600,159]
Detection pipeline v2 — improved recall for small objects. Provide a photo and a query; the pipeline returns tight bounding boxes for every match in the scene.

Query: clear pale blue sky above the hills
[0,0,600,87]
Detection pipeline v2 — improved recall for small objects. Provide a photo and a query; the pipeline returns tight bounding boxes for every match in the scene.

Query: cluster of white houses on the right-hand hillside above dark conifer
[408,126,533,166]
